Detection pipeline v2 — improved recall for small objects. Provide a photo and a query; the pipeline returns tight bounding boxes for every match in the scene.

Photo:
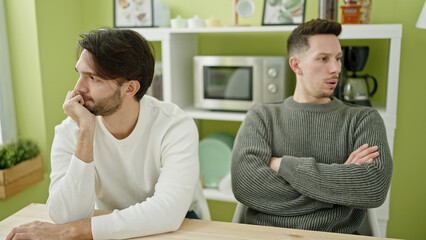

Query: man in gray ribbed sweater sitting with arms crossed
[231,19,392,233]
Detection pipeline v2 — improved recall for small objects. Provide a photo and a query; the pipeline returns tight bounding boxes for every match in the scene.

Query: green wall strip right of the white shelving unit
[372,0,426,239]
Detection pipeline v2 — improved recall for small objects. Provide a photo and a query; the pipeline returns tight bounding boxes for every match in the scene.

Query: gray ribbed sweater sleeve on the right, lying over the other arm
[278,111,392,208]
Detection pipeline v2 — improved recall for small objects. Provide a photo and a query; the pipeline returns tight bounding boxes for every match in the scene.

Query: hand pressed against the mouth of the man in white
[62,90,95,129]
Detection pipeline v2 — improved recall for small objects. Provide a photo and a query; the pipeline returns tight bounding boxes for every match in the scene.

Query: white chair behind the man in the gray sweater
[232,202,381,237]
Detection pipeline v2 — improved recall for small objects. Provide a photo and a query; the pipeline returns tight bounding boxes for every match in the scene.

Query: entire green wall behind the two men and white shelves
[0,0,426,239]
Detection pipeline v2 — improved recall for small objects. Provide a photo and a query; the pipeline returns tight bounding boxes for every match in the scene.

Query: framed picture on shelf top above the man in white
[114,0,154,27]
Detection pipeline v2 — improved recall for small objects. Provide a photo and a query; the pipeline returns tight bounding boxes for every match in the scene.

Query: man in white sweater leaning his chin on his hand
[8,29,205,239]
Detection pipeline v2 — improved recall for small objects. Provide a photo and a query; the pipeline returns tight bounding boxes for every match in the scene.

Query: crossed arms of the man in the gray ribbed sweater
[232,106,392,216]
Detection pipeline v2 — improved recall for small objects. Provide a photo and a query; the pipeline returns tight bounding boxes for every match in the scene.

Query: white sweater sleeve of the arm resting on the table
[91,117,199,239]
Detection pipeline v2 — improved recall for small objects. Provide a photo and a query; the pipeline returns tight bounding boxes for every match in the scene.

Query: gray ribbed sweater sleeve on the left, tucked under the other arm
[231,105,332,216]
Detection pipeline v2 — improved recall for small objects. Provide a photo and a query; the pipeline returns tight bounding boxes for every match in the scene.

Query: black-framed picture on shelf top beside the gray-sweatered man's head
[262,0,306,26]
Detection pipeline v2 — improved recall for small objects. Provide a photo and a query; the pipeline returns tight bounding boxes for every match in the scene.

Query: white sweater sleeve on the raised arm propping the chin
[47,119,95,224]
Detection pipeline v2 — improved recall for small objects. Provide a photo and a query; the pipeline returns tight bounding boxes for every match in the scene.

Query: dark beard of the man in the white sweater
[81,87,123,117]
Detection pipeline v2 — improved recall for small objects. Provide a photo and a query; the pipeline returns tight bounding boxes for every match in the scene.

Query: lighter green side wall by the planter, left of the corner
[0,0,50,219]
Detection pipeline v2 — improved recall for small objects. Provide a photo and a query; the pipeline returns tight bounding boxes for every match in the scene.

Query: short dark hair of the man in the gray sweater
[287,19,342,57]
